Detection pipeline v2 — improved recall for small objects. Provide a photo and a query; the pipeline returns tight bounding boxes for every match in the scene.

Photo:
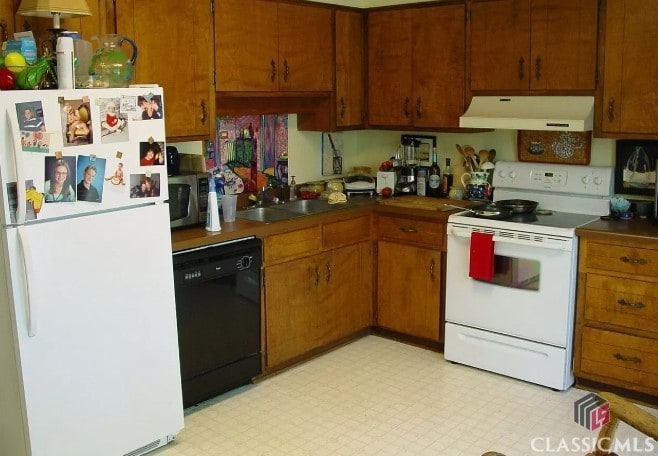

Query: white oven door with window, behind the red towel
[446,223,577,347]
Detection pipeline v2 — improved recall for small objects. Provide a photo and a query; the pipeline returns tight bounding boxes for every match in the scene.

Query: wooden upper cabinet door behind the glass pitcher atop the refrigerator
[115,0,215,138]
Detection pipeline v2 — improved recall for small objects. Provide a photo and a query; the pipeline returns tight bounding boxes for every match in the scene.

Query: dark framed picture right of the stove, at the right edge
[615,139,658,196]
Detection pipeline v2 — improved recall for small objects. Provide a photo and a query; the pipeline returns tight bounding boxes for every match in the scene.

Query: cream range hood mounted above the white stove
[459,96,594,131]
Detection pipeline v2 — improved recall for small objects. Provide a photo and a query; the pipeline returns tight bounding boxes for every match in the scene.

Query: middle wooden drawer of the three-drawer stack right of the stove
[585,274,658,335]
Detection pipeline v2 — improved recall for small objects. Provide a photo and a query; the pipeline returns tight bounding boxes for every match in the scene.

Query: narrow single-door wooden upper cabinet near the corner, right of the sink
[336,10,366,128]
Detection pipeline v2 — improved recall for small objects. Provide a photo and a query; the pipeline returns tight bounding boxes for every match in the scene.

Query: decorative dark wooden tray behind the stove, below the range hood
[517,130,592,165]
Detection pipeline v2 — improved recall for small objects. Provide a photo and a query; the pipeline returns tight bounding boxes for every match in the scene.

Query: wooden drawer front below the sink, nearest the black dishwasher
[263,225,321,263]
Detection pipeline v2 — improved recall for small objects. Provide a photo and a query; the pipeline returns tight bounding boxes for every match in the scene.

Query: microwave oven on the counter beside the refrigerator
[168,173,209,228]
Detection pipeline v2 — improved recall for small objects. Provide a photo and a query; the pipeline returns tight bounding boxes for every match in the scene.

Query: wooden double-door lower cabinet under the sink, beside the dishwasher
[263,215,374,370]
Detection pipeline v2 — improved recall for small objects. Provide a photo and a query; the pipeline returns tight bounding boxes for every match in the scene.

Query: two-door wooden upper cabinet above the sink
[215,0,334,92]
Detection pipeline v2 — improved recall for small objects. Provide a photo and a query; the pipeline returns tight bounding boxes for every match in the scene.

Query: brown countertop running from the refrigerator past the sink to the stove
[171,195,475,252]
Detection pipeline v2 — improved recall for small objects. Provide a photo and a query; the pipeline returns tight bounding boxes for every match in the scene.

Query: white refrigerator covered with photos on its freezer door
[0,86,183,456]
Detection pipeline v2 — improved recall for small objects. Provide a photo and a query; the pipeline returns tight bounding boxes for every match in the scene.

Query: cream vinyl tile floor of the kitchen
[152,336,658,456]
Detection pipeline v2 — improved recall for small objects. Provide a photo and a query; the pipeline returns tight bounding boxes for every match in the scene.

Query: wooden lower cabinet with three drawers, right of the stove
[574,235,658,396]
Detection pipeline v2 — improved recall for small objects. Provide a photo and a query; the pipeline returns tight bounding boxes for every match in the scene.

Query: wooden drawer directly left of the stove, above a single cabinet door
[377,216,445,248]
